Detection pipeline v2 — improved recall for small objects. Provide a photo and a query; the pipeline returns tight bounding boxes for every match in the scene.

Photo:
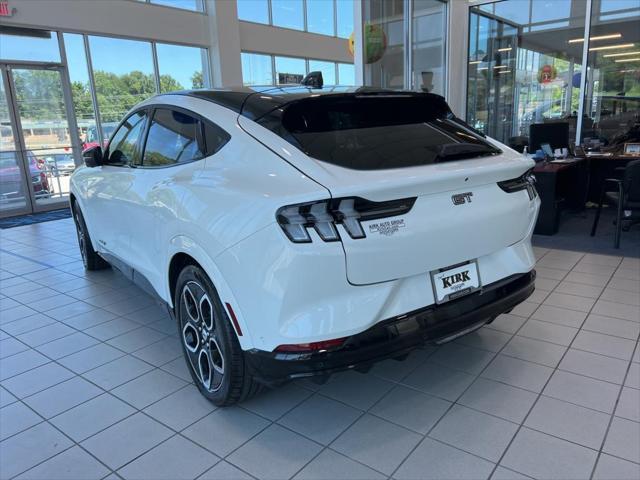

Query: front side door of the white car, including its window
[85,110,147,259]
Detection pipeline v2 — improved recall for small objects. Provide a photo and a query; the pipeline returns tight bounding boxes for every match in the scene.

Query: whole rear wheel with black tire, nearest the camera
[173,265,262,407]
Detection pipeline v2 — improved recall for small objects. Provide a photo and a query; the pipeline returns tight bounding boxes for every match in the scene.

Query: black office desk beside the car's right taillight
[533,158,588,235]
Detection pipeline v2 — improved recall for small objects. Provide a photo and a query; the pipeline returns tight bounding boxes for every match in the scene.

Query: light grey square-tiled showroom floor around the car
[0,220,640,480]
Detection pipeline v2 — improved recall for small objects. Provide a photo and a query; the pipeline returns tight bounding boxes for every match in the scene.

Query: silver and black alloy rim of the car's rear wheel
[179,280,225,392]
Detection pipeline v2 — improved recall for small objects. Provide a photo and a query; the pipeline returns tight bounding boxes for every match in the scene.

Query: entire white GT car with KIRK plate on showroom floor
[71,86,540,405]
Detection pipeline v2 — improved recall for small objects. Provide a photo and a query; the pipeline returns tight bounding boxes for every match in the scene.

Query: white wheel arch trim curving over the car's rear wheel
[165,236,254,350]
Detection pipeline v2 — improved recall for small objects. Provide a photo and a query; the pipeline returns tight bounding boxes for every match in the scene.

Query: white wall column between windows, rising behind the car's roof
[206,0,242,87]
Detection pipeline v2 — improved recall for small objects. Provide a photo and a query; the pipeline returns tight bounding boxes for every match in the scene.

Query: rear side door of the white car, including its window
[128,106,225,288]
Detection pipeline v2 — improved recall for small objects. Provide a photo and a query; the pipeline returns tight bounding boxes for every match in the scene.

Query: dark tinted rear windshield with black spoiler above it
[258,94,500,170]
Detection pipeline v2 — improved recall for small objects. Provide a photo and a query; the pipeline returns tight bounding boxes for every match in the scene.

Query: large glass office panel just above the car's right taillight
[467,0,586,148]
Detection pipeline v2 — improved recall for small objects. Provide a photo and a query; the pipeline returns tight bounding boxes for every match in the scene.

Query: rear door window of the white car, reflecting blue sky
[142,108,206,167]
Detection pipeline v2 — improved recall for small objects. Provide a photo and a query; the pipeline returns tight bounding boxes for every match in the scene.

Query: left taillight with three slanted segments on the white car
[276,197,416,243]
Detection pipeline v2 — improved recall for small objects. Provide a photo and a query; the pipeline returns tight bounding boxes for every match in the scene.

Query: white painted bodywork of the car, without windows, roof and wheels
[71,91,539,351]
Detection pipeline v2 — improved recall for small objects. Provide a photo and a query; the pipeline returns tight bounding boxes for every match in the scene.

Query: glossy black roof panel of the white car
[169,85,443,120]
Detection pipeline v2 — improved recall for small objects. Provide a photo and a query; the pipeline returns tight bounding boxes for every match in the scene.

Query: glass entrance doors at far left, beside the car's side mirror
[0,64,79,216]
